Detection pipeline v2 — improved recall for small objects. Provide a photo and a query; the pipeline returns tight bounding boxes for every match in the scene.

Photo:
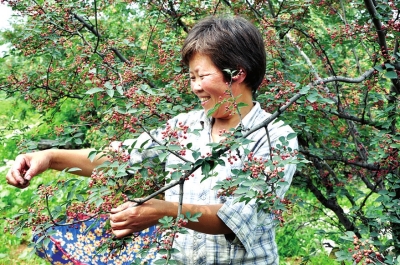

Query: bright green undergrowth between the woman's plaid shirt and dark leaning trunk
[276,186,339,265]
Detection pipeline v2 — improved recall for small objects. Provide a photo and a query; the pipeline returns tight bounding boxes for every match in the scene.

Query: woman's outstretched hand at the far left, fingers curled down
[6,151,51,189]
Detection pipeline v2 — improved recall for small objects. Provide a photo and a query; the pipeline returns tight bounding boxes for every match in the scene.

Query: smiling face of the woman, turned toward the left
[189,53,230,119]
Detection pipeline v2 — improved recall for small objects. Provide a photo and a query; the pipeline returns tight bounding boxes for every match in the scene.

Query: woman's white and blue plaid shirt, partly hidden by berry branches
[126,102,298,265]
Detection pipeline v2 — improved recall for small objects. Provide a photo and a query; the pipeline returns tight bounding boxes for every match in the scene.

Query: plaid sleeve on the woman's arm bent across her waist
[217,120,298,252]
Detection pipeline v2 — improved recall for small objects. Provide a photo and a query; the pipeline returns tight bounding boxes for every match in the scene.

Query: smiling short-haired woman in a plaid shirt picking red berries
[7,16,297,264]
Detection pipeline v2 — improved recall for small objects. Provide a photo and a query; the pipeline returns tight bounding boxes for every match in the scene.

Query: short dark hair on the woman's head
[182,16,266,94]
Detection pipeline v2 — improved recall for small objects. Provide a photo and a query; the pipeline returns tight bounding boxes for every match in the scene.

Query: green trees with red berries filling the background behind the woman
[0,0,400,264]
